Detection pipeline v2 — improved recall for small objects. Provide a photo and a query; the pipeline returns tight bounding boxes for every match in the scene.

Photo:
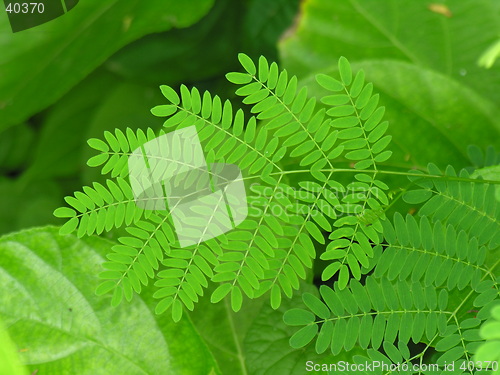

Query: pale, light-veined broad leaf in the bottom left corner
[0,227,218,375]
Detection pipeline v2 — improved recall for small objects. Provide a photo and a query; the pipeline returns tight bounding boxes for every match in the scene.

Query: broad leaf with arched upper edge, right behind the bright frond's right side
[301,59,500,168]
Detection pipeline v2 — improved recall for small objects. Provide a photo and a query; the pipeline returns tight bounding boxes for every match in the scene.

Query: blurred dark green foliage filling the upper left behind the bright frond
[0,0,299,234]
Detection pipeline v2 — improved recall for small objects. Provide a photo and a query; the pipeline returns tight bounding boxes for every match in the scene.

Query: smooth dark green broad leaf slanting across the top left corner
[0,0,213,129]
